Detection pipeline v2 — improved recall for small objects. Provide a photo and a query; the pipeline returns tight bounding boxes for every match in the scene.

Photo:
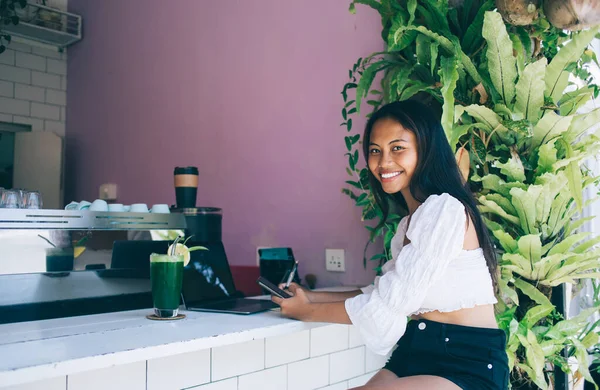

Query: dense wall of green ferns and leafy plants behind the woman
[342,0,600,389]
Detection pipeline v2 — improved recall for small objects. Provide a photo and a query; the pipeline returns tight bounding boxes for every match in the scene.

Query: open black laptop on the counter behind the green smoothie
[181,242,279,314]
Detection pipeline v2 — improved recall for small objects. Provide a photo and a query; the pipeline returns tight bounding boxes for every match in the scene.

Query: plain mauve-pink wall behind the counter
[66,0,383,286]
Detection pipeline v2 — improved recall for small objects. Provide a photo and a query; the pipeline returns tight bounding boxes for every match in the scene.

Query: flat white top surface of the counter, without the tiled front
[0,300,327,386]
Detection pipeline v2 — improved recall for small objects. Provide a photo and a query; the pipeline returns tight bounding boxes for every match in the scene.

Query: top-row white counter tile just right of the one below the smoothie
[211,339,265,381]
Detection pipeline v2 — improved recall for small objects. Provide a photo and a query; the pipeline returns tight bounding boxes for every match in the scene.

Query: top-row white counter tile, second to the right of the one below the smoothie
[265,330,310,367]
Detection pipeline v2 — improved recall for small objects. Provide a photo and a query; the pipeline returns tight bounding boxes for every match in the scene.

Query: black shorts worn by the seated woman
[384,320,510,390]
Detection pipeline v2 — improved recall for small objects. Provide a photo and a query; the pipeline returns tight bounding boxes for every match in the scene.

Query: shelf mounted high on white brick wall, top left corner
[2,3,81,50]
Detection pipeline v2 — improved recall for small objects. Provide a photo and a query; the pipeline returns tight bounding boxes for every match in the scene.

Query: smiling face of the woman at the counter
[368,118,418,194]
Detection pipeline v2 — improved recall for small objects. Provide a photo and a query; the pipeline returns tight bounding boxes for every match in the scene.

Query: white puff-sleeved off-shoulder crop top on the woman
[345,194,497,355]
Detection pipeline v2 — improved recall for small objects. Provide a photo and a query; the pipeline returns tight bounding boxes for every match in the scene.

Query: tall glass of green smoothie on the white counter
[150,253,183,317]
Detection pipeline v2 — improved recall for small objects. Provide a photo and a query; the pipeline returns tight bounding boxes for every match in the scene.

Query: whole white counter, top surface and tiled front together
[0,304,386,390]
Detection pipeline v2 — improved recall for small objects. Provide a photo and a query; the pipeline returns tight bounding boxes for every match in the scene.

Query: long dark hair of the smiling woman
[363,100,498,287]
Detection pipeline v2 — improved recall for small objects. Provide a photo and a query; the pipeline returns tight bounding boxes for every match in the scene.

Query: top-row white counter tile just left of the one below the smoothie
[67,362,146,390]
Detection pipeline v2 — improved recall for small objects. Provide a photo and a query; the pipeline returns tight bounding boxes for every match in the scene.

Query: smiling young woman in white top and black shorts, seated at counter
[272,101,509,390]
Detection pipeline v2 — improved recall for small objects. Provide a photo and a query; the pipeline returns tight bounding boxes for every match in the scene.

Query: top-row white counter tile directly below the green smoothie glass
[146,349,210,390]
